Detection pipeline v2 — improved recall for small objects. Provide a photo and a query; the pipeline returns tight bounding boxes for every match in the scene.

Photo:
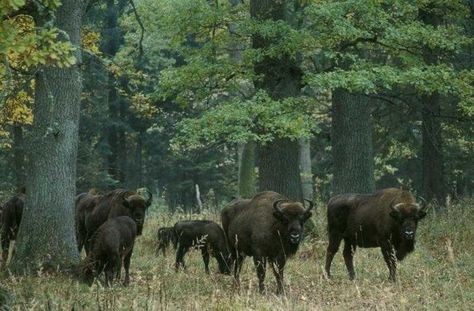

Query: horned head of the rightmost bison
[390,203,426,240]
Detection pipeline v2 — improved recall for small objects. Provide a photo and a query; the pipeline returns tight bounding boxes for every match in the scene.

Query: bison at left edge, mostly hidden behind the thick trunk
[0,189,25,267]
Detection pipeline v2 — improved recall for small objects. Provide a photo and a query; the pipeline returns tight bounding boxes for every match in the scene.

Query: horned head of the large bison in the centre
[273,200,314,244]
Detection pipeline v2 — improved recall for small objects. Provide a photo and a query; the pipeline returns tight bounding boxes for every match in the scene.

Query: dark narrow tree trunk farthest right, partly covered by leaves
[420,11,446,206]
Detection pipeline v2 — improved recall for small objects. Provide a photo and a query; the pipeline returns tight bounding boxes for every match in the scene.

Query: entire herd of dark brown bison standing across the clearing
[0,188,426,294]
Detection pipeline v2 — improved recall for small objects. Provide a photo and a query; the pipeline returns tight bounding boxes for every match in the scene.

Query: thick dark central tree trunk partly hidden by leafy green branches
[250,0,303,200]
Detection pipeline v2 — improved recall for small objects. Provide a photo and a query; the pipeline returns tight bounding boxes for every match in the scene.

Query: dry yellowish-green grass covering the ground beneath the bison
[0,201,474,310]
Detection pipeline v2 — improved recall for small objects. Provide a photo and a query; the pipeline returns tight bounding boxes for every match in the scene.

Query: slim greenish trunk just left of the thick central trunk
[239,142,256,198]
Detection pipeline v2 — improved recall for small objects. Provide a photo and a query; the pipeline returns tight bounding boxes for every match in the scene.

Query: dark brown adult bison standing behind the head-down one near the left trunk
[76,189,152,253]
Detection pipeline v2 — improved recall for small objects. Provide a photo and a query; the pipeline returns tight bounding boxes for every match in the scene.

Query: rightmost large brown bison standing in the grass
[326,188,426,281]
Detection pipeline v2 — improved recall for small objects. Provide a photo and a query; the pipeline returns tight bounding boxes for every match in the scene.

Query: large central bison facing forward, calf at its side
[221,191,313,294]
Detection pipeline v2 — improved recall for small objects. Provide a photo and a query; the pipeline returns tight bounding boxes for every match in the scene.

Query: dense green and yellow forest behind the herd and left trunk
[0,0,474,212]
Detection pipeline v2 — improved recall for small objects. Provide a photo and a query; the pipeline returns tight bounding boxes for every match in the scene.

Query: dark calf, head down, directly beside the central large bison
[174,220,230,274]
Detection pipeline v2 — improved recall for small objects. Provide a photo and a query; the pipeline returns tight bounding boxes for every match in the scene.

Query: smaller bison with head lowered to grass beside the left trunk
[84,216,137,286]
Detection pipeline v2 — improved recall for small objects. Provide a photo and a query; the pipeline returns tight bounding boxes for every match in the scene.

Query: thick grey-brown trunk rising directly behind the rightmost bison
[331,89,375,194]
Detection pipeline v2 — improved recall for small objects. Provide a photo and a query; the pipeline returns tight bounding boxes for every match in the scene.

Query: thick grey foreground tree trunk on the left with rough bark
[10,0,82,273]
